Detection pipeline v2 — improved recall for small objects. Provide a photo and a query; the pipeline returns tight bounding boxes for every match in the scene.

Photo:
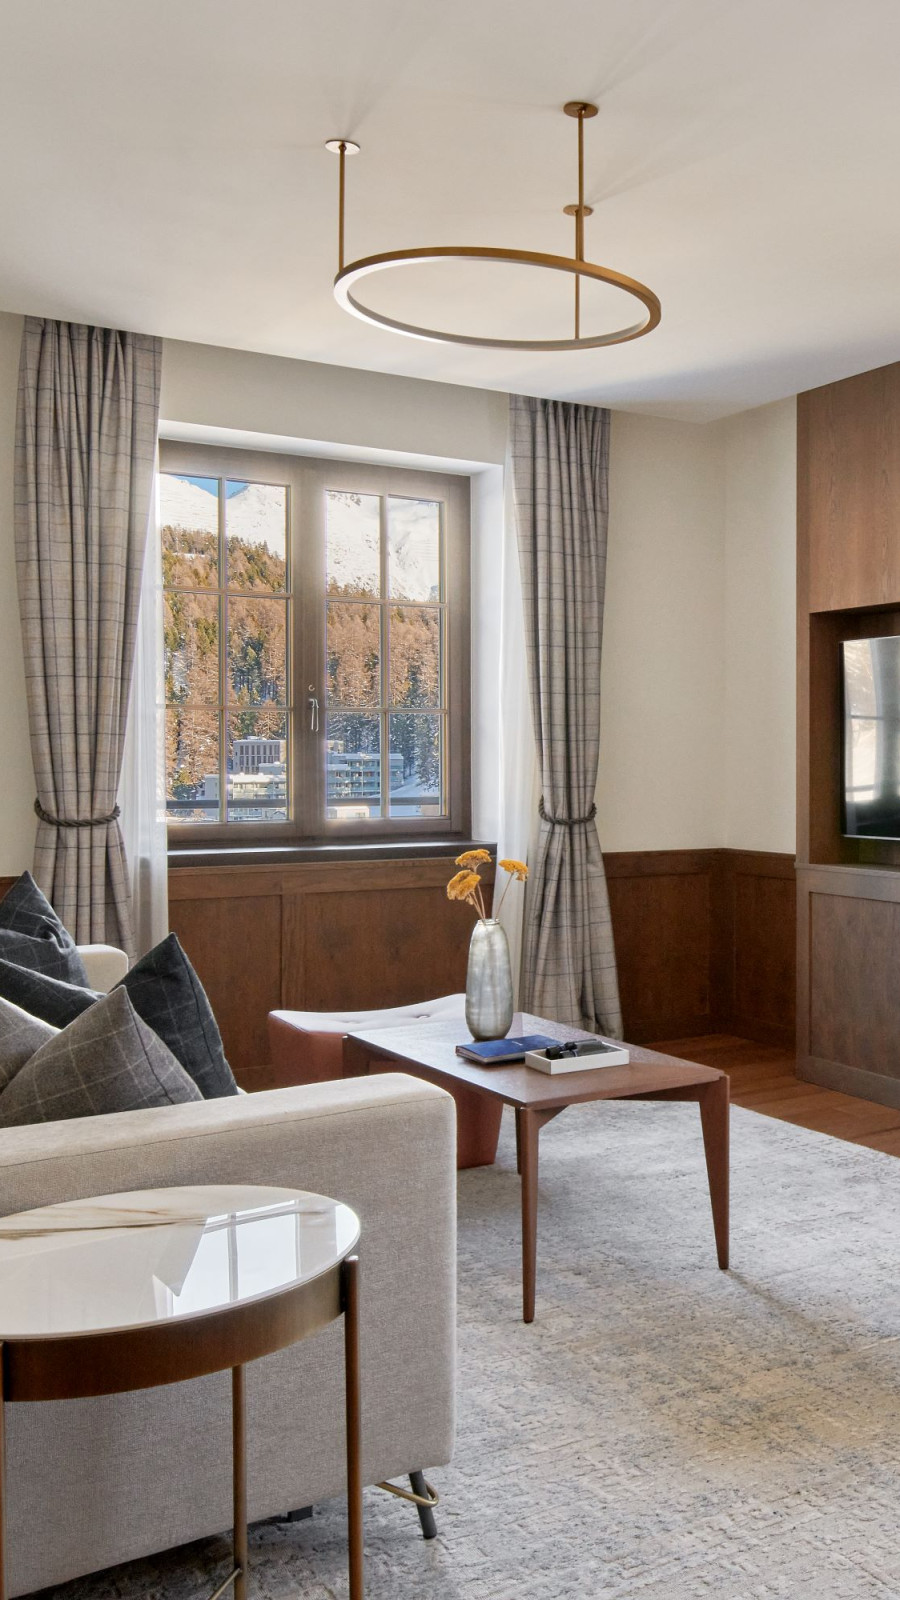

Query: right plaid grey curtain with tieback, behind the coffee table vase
[509,395,621,1035]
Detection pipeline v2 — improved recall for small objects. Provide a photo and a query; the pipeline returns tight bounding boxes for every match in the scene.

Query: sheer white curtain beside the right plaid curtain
[496,458,540,1003]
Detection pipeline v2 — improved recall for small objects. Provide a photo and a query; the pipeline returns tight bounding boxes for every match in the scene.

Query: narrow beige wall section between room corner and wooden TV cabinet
[719,400,798,854]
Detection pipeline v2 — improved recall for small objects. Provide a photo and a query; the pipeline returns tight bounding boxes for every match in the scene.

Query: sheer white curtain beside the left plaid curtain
[119,459,168,955]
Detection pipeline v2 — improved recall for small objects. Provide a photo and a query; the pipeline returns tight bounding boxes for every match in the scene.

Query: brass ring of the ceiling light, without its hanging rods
[335,245,663,350]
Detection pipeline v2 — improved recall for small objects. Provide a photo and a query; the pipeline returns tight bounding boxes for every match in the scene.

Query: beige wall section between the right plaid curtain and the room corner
[597,413,725,850]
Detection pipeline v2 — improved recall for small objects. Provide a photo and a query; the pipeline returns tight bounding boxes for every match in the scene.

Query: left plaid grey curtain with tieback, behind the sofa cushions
[16,317,162,954]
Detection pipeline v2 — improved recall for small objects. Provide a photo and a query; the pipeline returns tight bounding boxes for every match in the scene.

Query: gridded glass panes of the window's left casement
[160,472,291,826]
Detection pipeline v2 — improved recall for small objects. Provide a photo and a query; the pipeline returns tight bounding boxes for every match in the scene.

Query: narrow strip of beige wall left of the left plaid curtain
[0,312,35,877]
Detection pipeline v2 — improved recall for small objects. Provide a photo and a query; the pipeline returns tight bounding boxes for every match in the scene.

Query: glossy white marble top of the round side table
[0,1184,359,1339]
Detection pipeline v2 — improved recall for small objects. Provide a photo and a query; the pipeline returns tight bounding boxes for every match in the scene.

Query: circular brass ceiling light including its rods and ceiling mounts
[325,101,661,350]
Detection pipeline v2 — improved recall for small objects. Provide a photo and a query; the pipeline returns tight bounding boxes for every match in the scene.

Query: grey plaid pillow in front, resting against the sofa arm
[0,989,203,1128]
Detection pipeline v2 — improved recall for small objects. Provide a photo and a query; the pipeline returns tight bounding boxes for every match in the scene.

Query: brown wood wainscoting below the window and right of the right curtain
[0,850,794,1085]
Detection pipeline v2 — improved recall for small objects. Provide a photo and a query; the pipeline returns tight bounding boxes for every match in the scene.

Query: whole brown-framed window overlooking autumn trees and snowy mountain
[160,443,469,843]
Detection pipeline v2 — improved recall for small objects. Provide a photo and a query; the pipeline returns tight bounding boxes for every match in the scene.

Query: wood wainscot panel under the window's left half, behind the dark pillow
[170,869,282,1086]
